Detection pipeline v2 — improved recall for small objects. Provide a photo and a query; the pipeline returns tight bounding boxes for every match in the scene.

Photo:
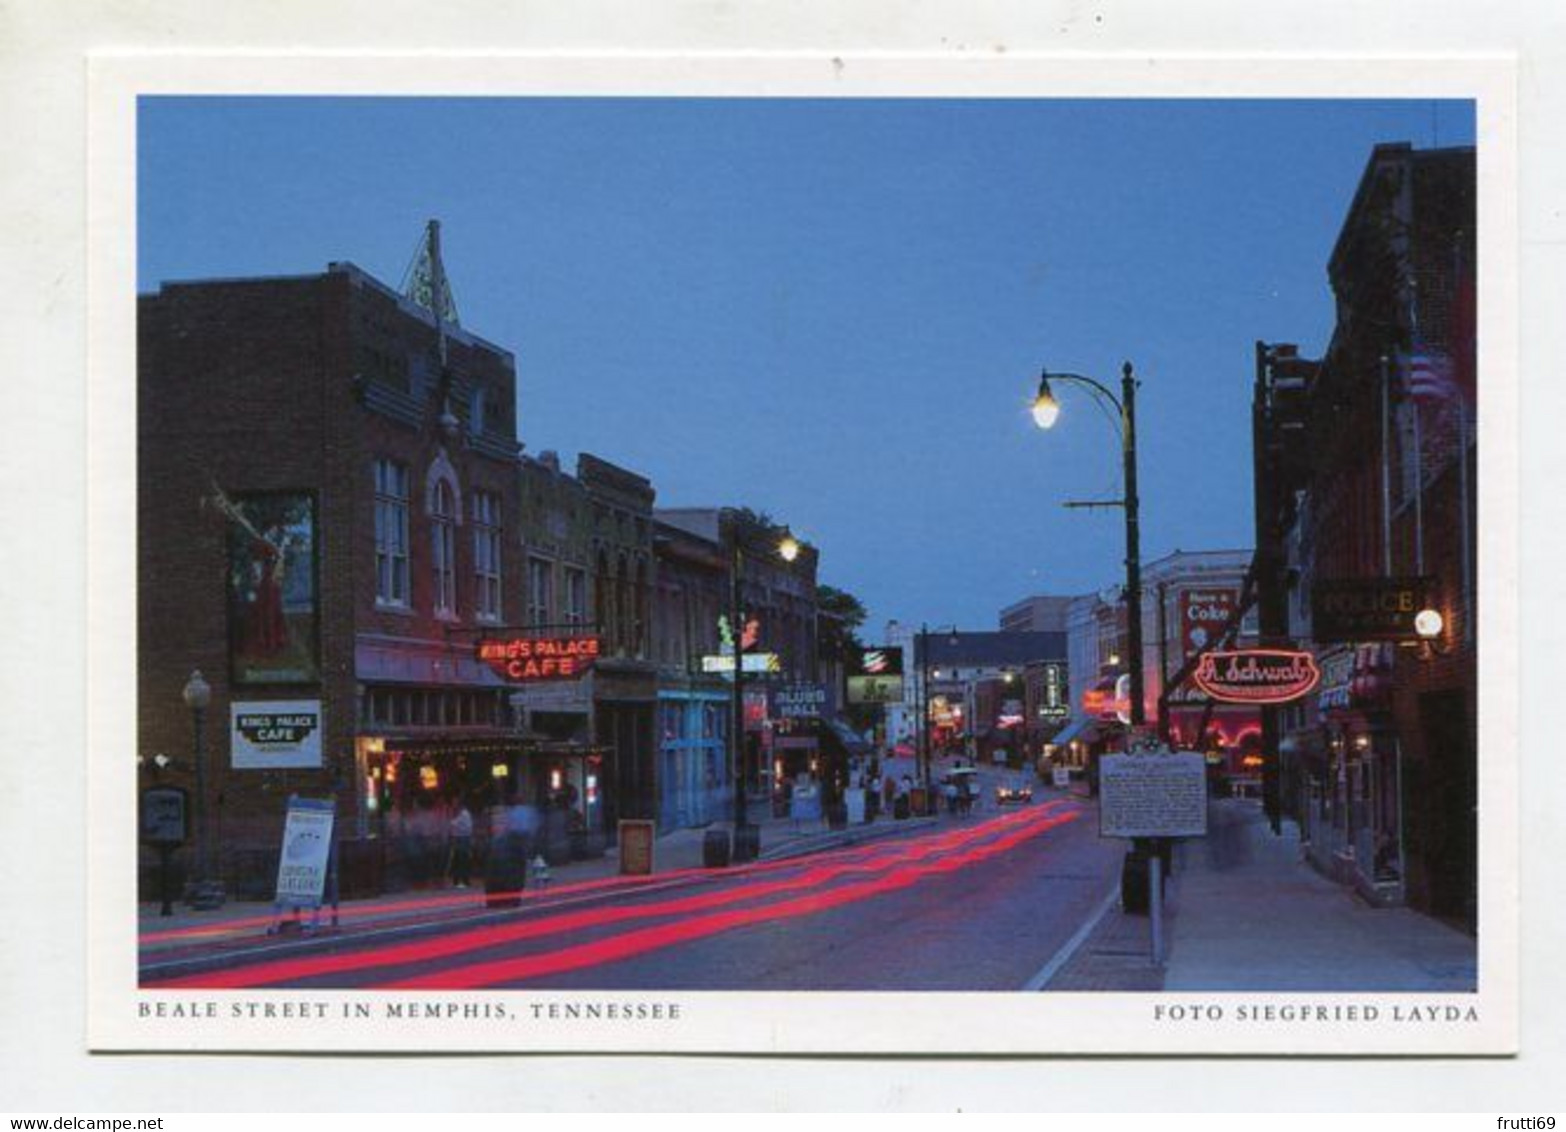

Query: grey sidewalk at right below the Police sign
[1045,800,1477,994]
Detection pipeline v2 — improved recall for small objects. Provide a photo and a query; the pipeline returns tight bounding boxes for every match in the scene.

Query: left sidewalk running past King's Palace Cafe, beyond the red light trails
[136,814,946,960]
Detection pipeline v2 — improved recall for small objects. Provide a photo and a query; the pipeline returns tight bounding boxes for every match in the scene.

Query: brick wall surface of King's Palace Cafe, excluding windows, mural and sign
[136,265,521,889]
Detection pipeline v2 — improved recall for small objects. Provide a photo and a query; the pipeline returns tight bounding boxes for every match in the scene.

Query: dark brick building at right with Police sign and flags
[1256,144,1478,927]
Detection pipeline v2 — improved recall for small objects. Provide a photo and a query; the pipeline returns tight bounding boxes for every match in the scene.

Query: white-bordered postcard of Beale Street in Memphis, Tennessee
[88,55,1519,1055]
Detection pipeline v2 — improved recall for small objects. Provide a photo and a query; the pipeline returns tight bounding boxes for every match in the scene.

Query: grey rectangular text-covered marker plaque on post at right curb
[1098,752,1207,838]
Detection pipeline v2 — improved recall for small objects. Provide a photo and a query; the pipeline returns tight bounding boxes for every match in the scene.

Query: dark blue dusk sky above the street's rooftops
[138,97,1474,628]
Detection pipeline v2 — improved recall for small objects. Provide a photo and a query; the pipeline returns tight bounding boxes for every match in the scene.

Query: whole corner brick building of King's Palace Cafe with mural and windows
[136,252,523,896]
